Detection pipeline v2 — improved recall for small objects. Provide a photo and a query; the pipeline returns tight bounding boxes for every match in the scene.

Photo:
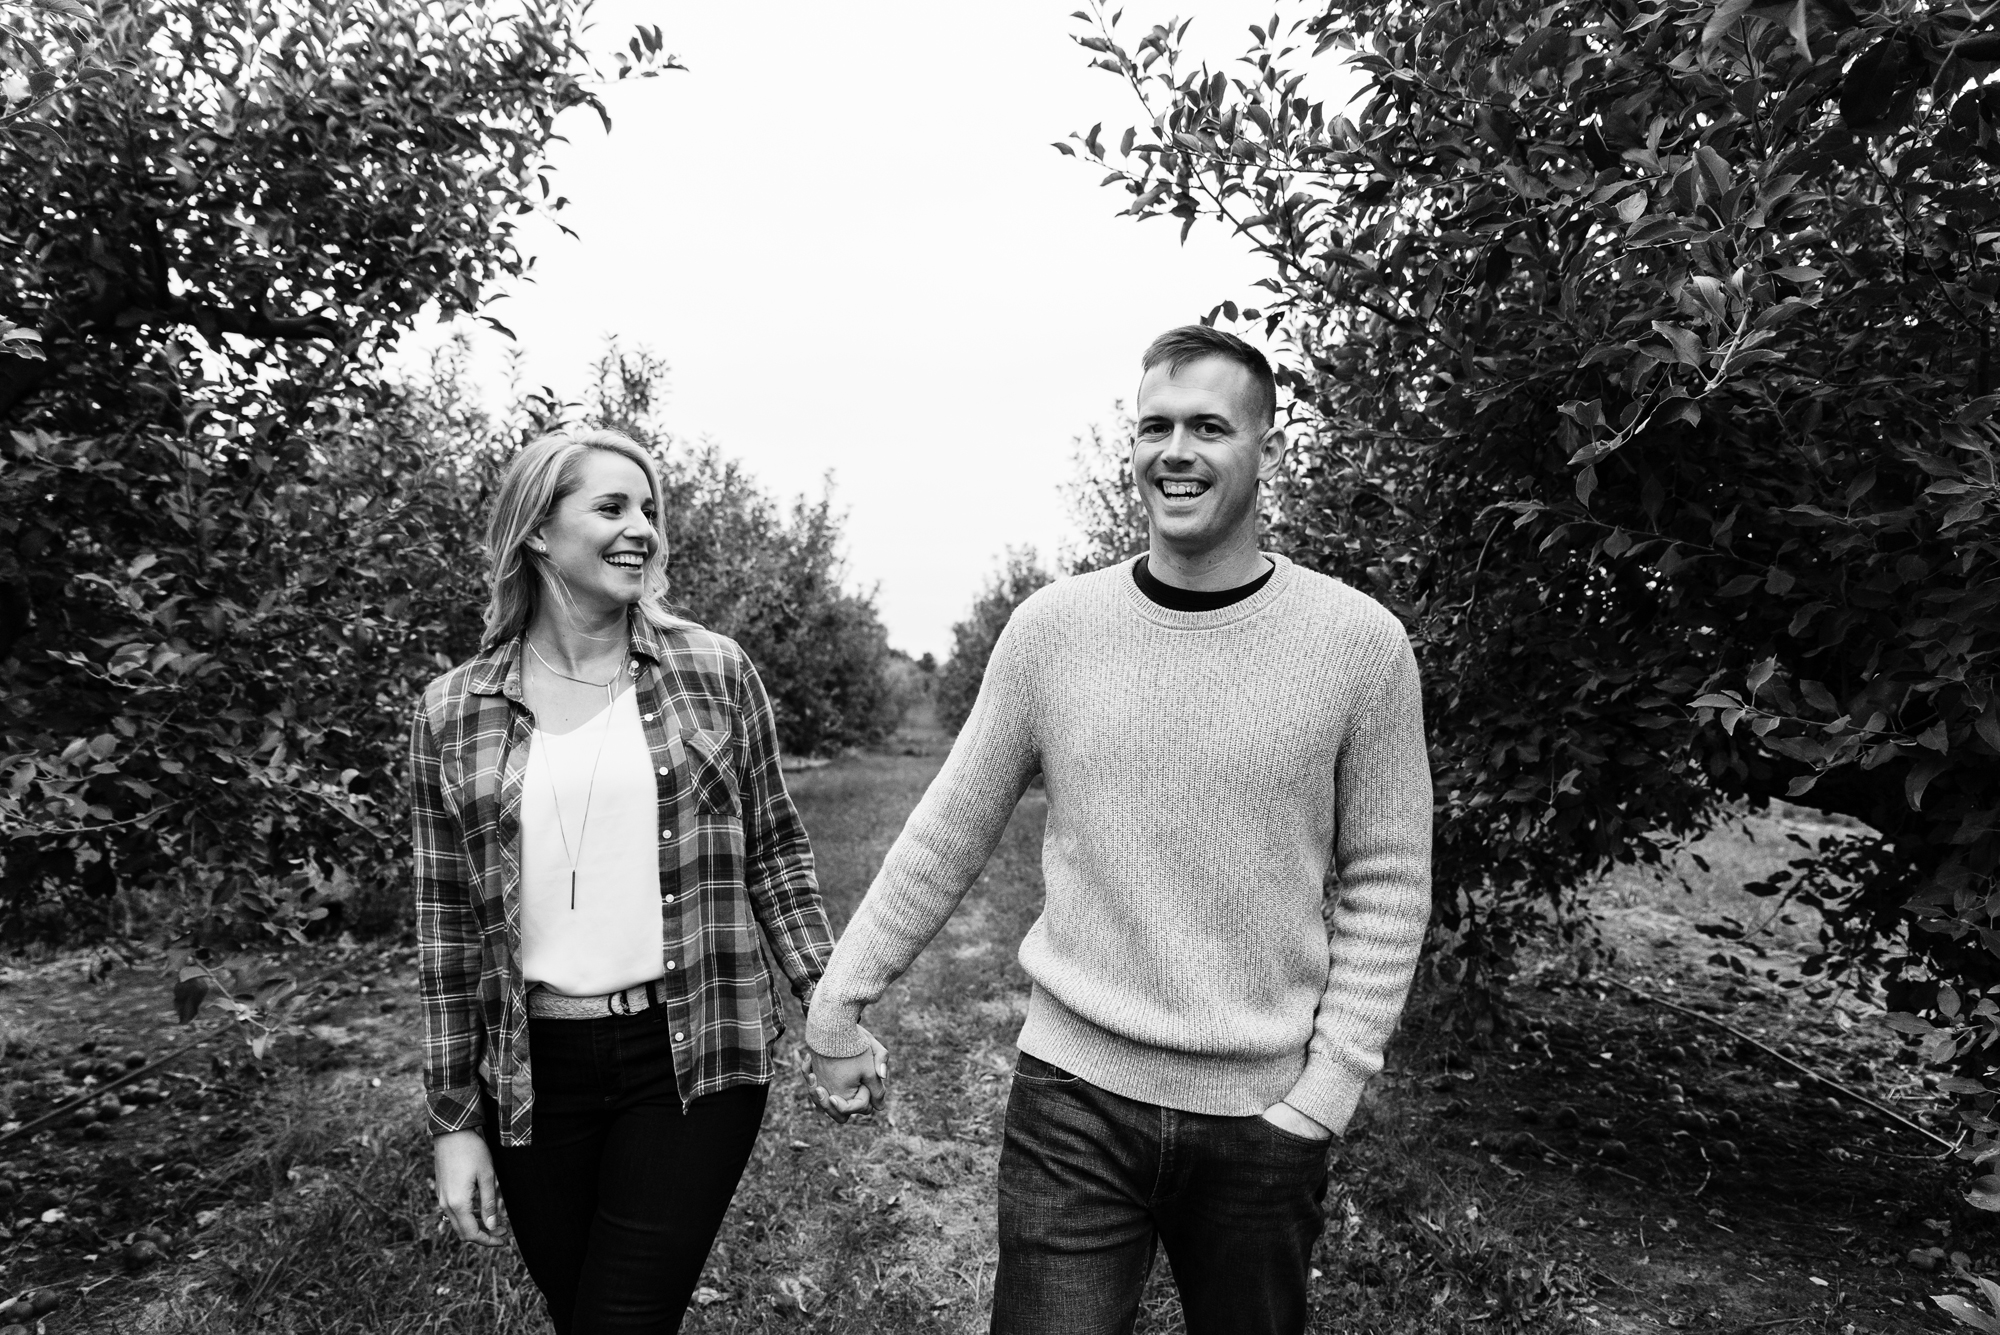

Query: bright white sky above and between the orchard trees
[394,0,1296,660]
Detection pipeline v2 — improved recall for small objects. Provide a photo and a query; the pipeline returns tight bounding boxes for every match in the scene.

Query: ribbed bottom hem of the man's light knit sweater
[1020,983,1310,1117]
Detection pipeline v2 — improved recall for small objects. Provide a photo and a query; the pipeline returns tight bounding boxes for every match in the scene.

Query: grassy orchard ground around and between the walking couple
[0,731,2000,1335]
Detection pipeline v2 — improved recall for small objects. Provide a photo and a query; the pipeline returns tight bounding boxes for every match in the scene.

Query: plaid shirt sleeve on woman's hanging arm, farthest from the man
[410,705,484,1135]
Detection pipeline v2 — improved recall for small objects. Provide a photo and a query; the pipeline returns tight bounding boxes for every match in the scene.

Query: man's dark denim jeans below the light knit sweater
[992,1053,1330,1335]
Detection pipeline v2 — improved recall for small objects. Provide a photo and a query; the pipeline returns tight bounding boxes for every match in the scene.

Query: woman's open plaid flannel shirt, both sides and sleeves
[410,618,832,1145]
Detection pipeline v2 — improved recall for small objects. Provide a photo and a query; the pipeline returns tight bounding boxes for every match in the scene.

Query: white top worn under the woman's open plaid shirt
[520,689,662,997]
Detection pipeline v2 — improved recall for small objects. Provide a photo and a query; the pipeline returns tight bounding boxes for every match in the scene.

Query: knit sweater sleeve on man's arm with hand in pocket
[1284,628,1432,1135]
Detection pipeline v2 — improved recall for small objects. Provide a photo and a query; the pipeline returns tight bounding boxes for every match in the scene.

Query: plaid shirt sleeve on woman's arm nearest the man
[738,660,834,1007]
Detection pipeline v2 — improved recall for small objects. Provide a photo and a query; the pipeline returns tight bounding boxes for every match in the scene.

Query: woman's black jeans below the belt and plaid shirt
[484,1005,768,1335]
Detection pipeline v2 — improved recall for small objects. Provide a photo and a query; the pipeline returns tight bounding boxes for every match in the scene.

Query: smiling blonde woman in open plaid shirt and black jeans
[410,432,888,1335]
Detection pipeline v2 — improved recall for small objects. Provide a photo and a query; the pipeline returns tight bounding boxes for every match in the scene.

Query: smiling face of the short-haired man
[1132,356,1284,562]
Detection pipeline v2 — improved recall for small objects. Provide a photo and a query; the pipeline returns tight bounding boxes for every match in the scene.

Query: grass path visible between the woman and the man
[688,755,1044,1331]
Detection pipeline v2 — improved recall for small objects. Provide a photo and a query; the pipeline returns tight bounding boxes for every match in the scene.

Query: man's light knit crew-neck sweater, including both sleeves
[806,558,1430,1133]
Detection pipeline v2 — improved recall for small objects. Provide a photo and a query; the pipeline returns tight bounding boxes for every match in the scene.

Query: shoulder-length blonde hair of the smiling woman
[480,430,688,650]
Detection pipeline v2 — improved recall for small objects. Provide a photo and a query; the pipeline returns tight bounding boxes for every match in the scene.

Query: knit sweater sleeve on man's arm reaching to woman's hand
[806,612,1040,1057]
